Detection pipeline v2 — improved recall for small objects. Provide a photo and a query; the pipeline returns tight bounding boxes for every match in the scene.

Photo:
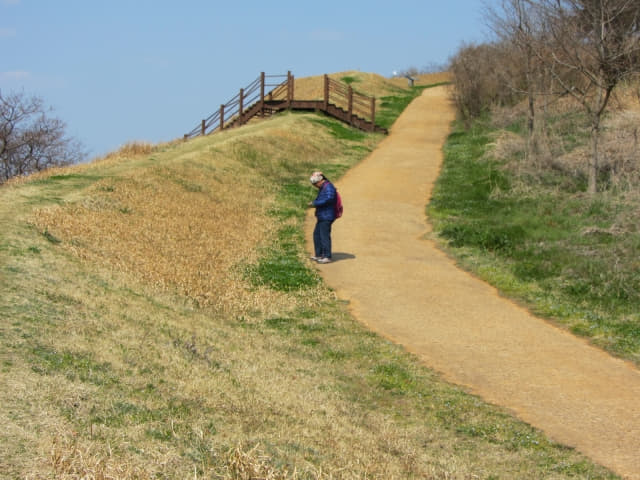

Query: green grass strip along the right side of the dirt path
[428,122,640,363]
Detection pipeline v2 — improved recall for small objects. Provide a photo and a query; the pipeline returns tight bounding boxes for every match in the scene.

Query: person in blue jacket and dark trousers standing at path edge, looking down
[308,172,337,263]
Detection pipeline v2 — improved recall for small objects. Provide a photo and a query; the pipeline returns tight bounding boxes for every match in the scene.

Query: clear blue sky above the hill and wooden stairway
[0,0,487,157]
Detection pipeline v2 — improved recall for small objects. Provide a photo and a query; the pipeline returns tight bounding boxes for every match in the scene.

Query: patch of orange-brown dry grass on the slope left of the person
[36,161,268,312]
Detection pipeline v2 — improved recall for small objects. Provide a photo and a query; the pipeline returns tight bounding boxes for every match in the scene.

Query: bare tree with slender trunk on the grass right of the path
[531,0,640,193]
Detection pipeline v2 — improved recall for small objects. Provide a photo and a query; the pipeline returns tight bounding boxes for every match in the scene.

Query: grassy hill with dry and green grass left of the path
[0,72,615,479]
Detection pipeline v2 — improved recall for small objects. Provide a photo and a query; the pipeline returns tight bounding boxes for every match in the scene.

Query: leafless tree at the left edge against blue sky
[0,91,85,184]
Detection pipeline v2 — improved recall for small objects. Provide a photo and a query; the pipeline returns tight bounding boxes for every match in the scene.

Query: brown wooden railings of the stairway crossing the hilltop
[184,72,387,140]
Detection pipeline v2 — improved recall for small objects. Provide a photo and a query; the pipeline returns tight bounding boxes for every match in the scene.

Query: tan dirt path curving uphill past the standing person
[308,87,640,479]
